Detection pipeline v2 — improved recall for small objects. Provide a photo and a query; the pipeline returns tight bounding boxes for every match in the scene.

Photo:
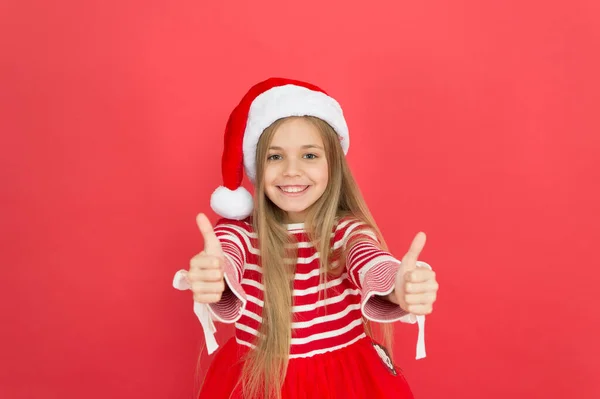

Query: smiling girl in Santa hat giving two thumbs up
[174,78,438,399]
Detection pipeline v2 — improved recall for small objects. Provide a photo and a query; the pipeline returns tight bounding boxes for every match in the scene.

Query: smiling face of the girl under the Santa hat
[264,118,329,223]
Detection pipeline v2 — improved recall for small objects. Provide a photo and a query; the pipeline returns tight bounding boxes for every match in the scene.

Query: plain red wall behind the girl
[0,0,600,399]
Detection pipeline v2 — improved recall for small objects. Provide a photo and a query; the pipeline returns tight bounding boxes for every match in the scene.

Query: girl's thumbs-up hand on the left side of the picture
[187,213,225,303]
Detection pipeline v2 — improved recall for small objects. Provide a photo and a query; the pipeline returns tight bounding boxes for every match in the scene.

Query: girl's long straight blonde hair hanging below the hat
[241,116,392,399]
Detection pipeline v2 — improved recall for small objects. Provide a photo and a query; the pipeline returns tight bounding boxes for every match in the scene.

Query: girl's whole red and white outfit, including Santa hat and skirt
[174,79,429,399]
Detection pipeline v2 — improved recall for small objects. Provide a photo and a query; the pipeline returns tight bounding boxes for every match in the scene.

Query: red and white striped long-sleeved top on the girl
[209,217,428,359]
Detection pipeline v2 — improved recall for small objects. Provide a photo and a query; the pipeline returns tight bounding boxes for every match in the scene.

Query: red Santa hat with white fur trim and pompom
[210,78,350,220]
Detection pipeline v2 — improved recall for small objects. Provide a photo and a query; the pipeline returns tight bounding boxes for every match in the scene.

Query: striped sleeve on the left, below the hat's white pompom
[209,219,250,324]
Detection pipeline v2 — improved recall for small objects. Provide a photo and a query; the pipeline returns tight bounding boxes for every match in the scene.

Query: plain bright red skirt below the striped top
[200,337,413,399]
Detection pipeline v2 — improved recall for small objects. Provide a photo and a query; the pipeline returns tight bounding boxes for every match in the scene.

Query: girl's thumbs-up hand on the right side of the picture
[390,232,439,316]
